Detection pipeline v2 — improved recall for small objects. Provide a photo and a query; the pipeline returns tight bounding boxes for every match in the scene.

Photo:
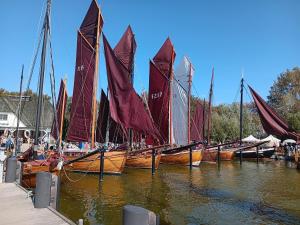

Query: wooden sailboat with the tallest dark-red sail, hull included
[64,0,126,174]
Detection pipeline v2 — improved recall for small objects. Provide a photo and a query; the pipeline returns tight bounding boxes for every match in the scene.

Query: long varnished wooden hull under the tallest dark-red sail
[65,151,127,174]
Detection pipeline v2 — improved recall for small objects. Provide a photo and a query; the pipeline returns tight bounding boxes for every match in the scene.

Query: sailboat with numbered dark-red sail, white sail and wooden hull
[148,38,202,165]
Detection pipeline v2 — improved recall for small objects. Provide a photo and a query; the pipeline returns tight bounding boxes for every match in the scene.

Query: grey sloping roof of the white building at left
[0,95,53,129]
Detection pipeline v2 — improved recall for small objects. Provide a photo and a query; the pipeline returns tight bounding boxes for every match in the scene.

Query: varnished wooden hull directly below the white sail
[160,149,202,166]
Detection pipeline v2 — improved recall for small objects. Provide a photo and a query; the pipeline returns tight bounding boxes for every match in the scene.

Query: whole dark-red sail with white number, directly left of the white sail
[148,38,176,144]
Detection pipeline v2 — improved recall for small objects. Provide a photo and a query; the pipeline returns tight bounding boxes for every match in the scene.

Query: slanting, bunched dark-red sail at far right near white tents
[249,86,300,140]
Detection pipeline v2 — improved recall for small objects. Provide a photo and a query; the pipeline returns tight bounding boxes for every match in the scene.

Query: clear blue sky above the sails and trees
[0,0,300,104]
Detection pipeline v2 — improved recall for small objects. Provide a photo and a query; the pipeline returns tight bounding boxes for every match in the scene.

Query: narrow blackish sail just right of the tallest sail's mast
[96,90,109,143]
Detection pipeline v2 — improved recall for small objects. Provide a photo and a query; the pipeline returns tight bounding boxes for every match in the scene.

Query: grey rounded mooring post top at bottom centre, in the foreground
[122,205,159,225]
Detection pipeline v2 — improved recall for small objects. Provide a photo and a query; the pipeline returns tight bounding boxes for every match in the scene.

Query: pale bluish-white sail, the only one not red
[171,57,194,145]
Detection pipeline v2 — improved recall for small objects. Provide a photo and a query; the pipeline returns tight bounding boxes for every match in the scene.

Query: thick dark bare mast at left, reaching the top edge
[34,0,51,157]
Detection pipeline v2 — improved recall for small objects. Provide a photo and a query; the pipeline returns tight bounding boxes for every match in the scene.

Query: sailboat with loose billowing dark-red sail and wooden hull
[103,30,160,168]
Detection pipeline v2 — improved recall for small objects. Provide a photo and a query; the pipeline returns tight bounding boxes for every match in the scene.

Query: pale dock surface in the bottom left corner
[0,183,75,225]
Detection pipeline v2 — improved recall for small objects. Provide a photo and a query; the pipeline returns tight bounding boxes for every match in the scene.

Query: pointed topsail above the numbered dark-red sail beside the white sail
[153,38,176,78]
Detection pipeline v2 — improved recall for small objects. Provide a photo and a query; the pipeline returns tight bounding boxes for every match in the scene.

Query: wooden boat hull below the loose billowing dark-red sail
[126,151,161,169]
